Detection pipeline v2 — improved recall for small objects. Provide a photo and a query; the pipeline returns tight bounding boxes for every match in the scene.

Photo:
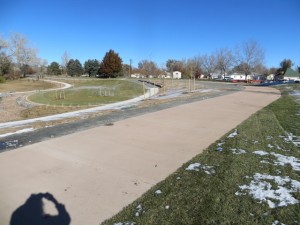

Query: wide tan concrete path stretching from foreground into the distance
[0,87,280,225]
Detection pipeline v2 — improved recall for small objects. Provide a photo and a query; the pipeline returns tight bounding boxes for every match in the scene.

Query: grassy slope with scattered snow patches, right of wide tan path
[103,85,300,225]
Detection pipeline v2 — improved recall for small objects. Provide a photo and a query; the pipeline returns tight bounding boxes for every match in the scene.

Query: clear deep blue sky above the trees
[0,0,300,67]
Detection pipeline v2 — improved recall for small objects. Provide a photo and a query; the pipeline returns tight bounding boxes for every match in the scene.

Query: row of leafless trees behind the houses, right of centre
[134,40,267,78]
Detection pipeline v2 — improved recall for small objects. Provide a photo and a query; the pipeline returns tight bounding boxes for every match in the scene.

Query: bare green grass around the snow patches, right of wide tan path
[103,86,300,225]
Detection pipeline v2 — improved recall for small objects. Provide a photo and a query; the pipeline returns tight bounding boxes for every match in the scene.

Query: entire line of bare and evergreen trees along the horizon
[0,33,300,80]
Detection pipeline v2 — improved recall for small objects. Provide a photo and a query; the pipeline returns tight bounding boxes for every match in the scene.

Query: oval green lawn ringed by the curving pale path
[29,80,143,106]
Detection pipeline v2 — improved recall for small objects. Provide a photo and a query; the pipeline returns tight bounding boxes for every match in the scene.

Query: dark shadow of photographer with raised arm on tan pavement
[10,193,71,225]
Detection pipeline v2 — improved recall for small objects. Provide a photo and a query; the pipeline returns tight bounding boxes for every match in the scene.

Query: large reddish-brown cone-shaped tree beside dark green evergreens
[99,50,122,77]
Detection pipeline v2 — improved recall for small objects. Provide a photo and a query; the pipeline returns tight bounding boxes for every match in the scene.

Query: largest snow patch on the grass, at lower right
[235,173,300,208]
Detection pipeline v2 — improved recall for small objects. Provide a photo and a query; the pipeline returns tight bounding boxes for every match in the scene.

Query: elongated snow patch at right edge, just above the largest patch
[253,151,300,171]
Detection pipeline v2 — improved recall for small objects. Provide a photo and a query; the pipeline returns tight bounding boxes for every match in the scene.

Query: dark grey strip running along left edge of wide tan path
[0,82,244,153]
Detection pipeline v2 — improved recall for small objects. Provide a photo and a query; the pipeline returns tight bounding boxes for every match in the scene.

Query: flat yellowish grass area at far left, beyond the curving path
[0,79,57,93]
